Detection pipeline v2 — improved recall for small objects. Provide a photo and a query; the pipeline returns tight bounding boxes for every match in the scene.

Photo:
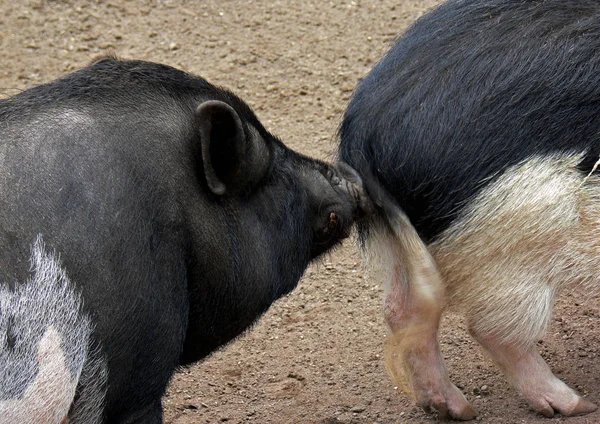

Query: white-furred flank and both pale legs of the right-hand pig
[367,153,600,419]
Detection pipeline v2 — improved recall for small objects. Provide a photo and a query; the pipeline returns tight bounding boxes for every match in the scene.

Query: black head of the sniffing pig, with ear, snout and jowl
[182,95,369,363]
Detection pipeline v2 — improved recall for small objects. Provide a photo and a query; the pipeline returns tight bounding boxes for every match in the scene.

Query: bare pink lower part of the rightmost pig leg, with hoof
[472,331,597,417]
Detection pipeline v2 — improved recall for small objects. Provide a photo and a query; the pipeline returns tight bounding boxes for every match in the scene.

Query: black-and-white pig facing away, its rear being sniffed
[340,0,600,419]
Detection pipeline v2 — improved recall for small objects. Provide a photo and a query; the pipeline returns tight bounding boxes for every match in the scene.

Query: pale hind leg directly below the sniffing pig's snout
[367,210,475,420]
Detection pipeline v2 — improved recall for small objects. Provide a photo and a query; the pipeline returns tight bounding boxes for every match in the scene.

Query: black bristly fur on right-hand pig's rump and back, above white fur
[340,0,600,241]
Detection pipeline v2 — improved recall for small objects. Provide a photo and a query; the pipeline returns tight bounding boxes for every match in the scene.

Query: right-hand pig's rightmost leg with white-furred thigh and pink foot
[430,156,600,416]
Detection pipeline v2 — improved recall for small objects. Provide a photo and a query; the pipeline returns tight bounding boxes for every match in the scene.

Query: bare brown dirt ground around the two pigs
[0,0,600,424]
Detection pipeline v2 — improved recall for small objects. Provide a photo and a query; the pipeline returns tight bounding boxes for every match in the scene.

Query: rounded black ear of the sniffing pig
[195,100,269,196]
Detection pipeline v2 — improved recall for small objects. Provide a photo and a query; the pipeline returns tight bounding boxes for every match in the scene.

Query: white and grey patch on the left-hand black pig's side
[0,236,106,424]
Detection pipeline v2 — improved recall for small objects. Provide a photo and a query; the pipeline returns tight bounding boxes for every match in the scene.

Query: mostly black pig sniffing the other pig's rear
[0,57,370,424]
